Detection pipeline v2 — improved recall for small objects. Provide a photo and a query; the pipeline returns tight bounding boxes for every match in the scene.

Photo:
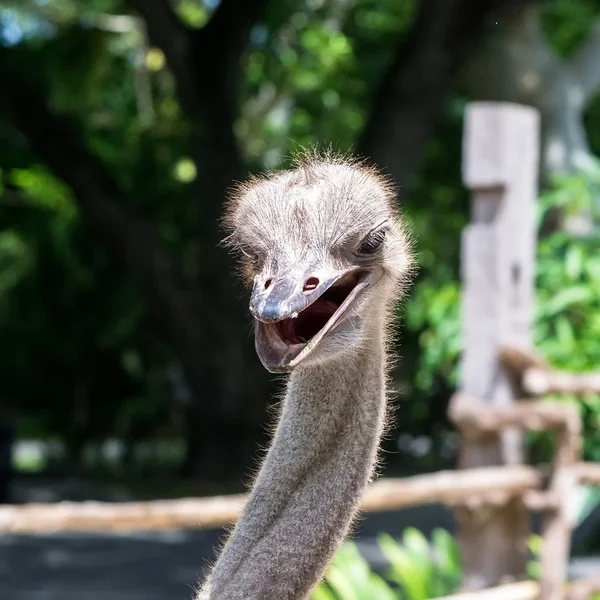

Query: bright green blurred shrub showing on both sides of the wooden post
[406,176,600,461]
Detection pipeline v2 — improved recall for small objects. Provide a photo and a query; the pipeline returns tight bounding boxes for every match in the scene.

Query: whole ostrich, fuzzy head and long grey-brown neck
[196,155,411,600]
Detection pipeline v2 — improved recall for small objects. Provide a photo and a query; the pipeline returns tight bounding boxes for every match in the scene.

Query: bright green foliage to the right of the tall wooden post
[534,176,600,461]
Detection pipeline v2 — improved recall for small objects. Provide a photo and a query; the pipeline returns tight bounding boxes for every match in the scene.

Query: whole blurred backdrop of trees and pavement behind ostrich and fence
[0,0,600,600]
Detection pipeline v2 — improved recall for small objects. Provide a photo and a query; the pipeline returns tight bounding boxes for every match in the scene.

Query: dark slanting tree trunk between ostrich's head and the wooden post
[358,0,531,185]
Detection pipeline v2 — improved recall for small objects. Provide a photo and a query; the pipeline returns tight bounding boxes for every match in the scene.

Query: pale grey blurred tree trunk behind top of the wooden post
[464,2,600,234]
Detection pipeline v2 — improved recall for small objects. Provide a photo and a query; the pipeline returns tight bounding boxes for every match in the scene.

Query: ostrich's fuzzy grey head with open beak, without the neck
[225,157,410,372]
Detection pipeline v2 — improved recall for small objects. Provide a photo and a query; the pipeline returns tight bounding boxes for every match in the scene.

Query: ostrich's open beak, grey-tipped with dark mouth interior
[250,267,380,373]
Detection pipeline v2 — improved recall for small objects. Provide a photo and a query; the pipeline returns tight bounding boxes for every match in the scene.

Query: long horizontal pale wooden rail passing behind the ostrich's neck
[0,465,542,534]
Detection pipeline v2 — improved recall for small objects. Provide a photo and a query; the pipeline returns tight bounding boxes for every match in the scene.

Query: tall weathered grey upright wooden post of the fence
[457,103,539,589]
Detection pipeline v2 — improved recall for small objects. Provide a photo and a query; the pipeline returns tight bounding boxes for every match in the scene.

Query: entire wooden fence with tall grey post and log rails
[0,103,600,600]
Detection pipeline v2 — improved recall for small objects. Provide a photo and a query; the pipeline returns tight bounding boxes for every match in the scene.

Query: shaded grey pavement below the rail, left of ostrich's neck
[0,532,216,600]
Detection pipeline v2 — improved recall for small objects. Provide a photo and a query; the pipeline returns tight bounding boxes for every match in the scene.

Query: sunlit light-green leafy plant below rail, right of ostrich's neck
[312,528,462,600]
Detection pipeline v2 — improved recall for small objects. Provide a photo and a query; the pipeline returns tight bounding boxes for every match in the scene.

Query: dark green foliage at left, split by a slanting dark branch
[0,0,202,468]
